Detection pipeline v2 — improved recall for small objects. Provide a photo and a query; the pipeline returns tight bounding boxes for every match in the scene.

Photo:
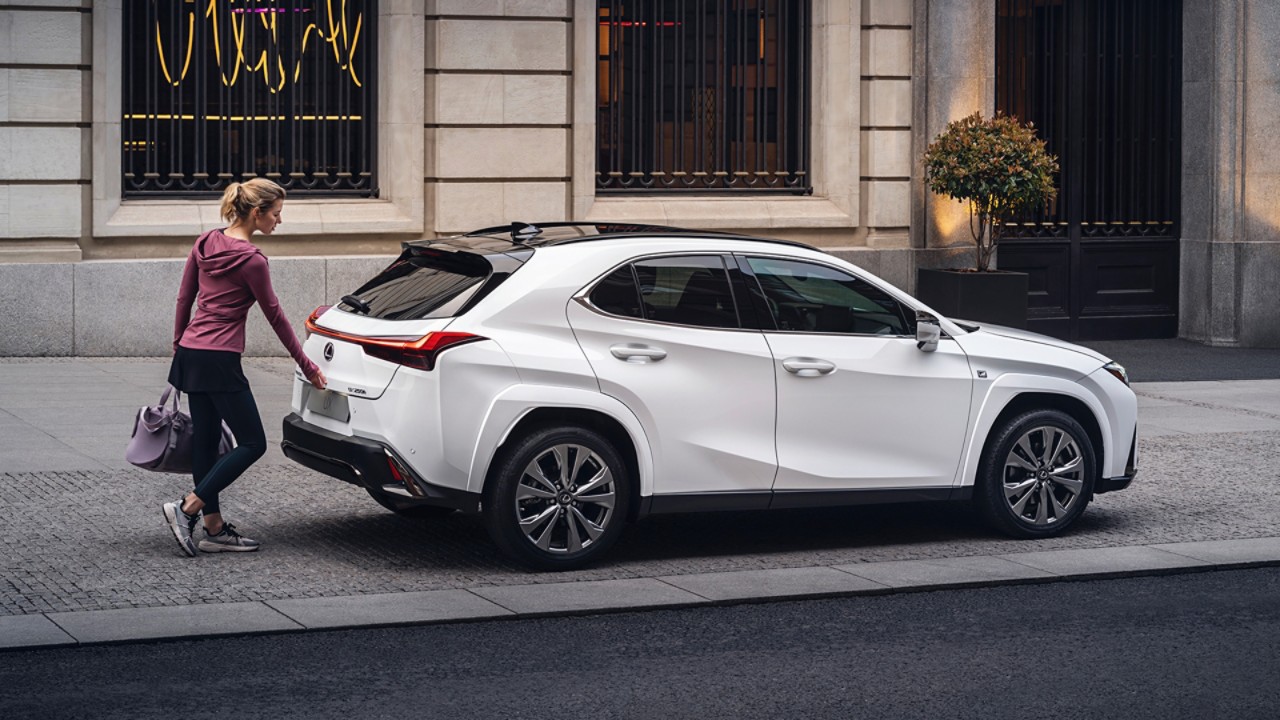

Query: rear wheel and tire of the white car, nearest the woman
[484,427,631,570]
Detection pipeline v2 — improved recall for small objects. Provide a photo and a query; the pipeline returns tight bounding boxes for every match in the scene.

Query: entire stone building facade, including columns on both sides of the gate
[0,0,1280,356]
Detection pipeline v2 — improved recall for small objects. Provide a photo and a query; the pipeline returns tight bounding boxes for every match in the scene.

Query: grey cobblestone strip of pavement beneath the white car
[0,422,1280,615]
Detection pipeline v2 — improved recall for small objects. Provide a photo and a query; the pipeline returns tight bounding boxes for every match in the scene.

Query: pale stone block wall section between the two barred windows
[426,0,573,234]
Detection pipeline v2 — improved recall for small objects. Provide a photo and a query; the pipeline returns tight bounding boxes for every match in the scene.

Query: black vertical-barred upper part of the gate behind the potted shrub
[996,0,1183,238]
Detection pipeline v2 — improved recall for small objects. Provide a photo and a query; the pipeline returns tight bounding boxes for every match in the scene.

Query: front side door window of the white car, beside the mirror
[746,258,915,336]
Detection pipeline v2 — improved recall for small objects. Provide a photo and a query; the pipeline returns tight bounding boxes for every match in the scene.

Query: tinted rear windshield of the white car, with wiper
[338,249,493,320]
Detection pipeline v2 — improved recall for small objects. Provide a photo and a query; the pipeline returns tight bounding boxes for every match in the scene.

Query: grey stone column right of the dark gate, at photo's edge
[1179,0,1280,347]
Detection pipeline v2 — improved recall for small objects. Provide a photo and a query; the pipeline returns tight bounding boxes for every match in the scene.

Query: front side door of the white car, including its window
[742,256,973,492]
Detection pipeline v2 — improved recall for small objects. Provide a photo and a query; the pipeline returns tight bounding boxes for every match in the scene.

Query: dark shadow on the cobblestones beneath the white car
[272,502,1080,573]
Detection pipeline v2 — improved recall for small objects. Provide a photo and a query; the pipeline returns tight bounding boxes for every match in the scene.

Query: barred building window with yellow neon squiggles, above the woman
[120,0,378,197]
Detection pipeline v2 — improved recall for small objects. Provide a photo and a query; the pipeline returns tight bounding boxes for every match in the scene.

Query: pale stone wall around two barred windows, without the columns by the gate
[0,0,913,355]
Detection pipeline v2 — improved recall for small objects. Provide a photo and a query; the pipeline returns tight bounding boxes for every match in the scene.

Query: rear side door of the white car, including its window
[568,255,777,497]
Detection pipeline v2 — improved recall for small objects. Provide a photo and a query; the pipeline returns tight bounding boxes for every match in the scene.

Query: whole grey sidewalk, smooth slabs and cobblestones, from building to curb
[0,359,1280,615]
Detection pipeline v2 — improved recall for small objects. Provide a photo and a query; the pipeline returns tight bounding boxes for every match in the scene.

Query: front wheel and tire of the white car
[974,410,1097,538]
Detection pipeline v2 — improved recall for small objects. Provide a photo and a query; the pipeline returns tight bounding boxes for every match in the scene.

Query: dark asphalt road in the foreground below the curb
[0,568,1280,720]
